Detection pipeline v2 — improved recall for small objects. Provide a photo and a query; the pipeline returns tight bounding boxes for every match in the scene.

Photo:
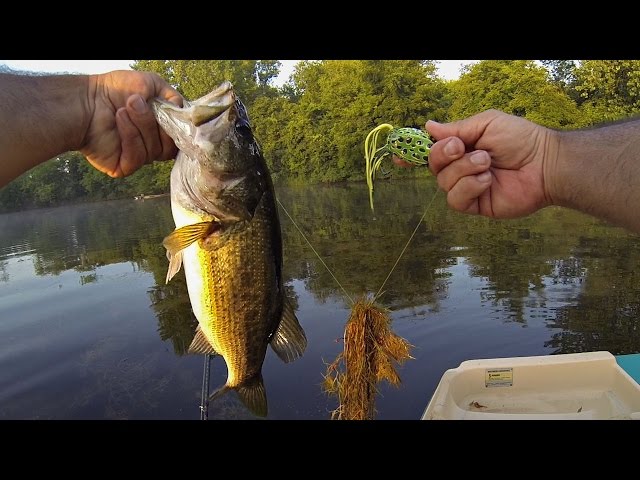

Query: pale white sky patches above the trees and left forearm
[0,60,475,85]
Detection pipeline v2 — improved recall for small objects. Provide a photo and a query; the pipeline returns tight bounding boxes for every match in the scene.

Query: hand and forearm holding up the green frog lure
[394,110,640,232]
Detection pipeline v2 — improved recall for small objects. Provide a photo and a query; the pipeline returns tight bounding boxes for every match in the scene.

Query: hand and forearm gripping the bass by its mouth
[0,70,182,187]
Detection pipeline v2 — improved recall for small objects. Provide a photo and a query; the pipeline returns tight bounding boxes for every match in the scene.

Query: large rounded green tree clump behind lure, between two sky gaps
[252,60,448,182]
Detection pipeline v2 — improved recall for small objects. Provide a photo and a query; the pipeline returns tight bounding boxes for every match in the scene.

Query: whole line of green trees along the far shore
[0,60,640,211]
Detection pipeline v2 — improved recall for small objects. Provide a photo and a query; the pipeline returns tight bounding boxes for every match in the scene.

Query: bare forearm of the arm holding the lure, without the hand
[545,120,640,233]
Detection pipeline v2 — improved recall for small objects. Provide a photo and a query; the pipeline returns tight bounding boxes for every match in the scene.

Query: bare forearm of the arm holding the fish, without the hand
[0,74,92,187]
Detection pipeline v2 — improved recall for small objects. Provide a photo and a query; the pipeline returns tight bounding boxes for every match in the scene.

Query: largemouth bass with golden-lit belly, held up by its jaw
[152,82,307,416]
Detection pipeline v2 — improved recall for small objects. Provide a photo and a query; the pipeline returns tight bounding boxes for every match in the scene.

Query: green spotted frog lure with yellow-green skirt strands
[364,123,433,210]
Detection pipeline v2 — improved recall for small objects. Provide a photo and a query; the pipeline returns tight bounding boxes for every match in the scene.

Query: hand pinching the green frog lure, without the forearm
[396,110,556,218]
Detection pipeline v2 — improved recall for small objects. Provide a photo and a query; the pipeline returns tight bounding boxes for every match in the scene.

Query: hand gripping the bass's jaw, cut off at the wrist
[79,70,182,178]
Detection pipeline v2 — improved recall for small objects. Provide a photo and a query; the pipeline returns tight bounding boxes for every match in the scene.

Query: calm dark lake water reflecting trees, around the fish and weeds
[0,179,640,419]
